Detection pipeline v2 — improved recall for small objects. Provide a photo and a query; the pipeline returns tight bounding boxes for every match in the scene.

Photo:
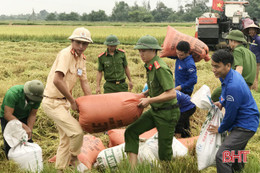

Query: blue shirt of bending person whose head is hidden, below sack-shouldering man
[176,90,196,113]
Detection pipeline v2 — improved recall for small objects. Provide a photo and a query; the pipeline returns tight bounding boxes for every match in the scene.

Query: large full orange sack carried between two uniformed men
[76,92,144,133]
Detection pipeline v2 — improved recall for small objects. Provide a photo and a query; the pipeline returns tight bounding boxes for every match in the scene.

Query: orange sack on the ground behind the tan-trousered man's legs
[48,135,106,169]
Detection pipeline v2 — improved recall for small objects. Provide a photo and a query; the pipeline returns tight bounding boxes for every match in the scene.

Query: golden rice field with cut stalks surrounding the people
[0,25,260,173]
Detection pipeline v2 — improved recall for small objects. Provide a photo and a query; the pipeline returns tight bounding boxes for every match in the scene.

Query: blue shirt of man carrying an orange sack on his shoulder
[169,55,197,93]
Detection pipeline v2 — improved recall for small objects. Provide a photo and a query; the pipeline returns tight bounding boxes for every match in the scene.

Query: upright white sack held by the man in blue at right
[191,85,226,170]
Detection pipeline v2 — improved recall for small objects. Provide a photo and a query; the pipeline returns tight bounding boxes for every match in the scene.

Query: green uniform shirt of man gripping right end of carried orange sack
[145,56,177,108]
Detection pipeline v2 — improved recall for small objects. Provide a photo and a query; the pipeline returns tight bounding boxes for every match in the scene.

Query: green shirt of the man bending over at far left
[0,85,41,119]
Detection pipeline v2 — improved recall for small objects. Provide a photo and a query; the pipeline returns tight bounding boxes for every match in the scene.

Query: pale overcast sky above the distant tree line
[0,0,212,15]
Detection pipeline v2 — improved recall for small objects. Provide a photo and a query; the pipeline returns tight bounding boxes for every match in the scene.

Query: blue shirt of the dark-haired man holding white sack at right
[218,69,259,133]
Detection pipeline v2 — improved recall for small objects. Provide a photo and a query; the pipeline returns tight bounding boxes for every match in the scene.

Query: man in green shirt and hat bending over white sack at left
[0,80,44,158]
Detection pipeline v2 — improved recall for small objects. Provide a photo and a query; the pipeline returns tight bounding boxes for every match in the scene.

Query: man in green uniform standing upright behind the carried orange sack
[96,35,133,94]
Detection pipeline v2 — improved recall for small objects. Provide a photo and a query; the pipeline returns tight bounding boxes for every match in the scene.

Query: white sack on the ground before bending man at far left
[4,119,43,172]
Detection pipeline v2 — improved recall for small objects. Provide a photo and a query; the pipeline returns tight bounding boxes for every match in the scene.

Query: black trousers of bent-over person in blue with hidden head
[175,106,196,138]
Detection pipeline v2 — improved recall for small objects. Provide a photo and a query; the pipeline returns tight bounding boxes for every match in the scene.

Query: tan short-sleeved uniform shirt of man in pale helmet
[44,46,86,98]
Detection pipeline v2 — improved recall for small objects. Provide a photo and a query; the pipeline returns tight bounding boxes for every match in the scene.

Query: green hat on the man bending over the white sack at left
[24,80,44,102]
